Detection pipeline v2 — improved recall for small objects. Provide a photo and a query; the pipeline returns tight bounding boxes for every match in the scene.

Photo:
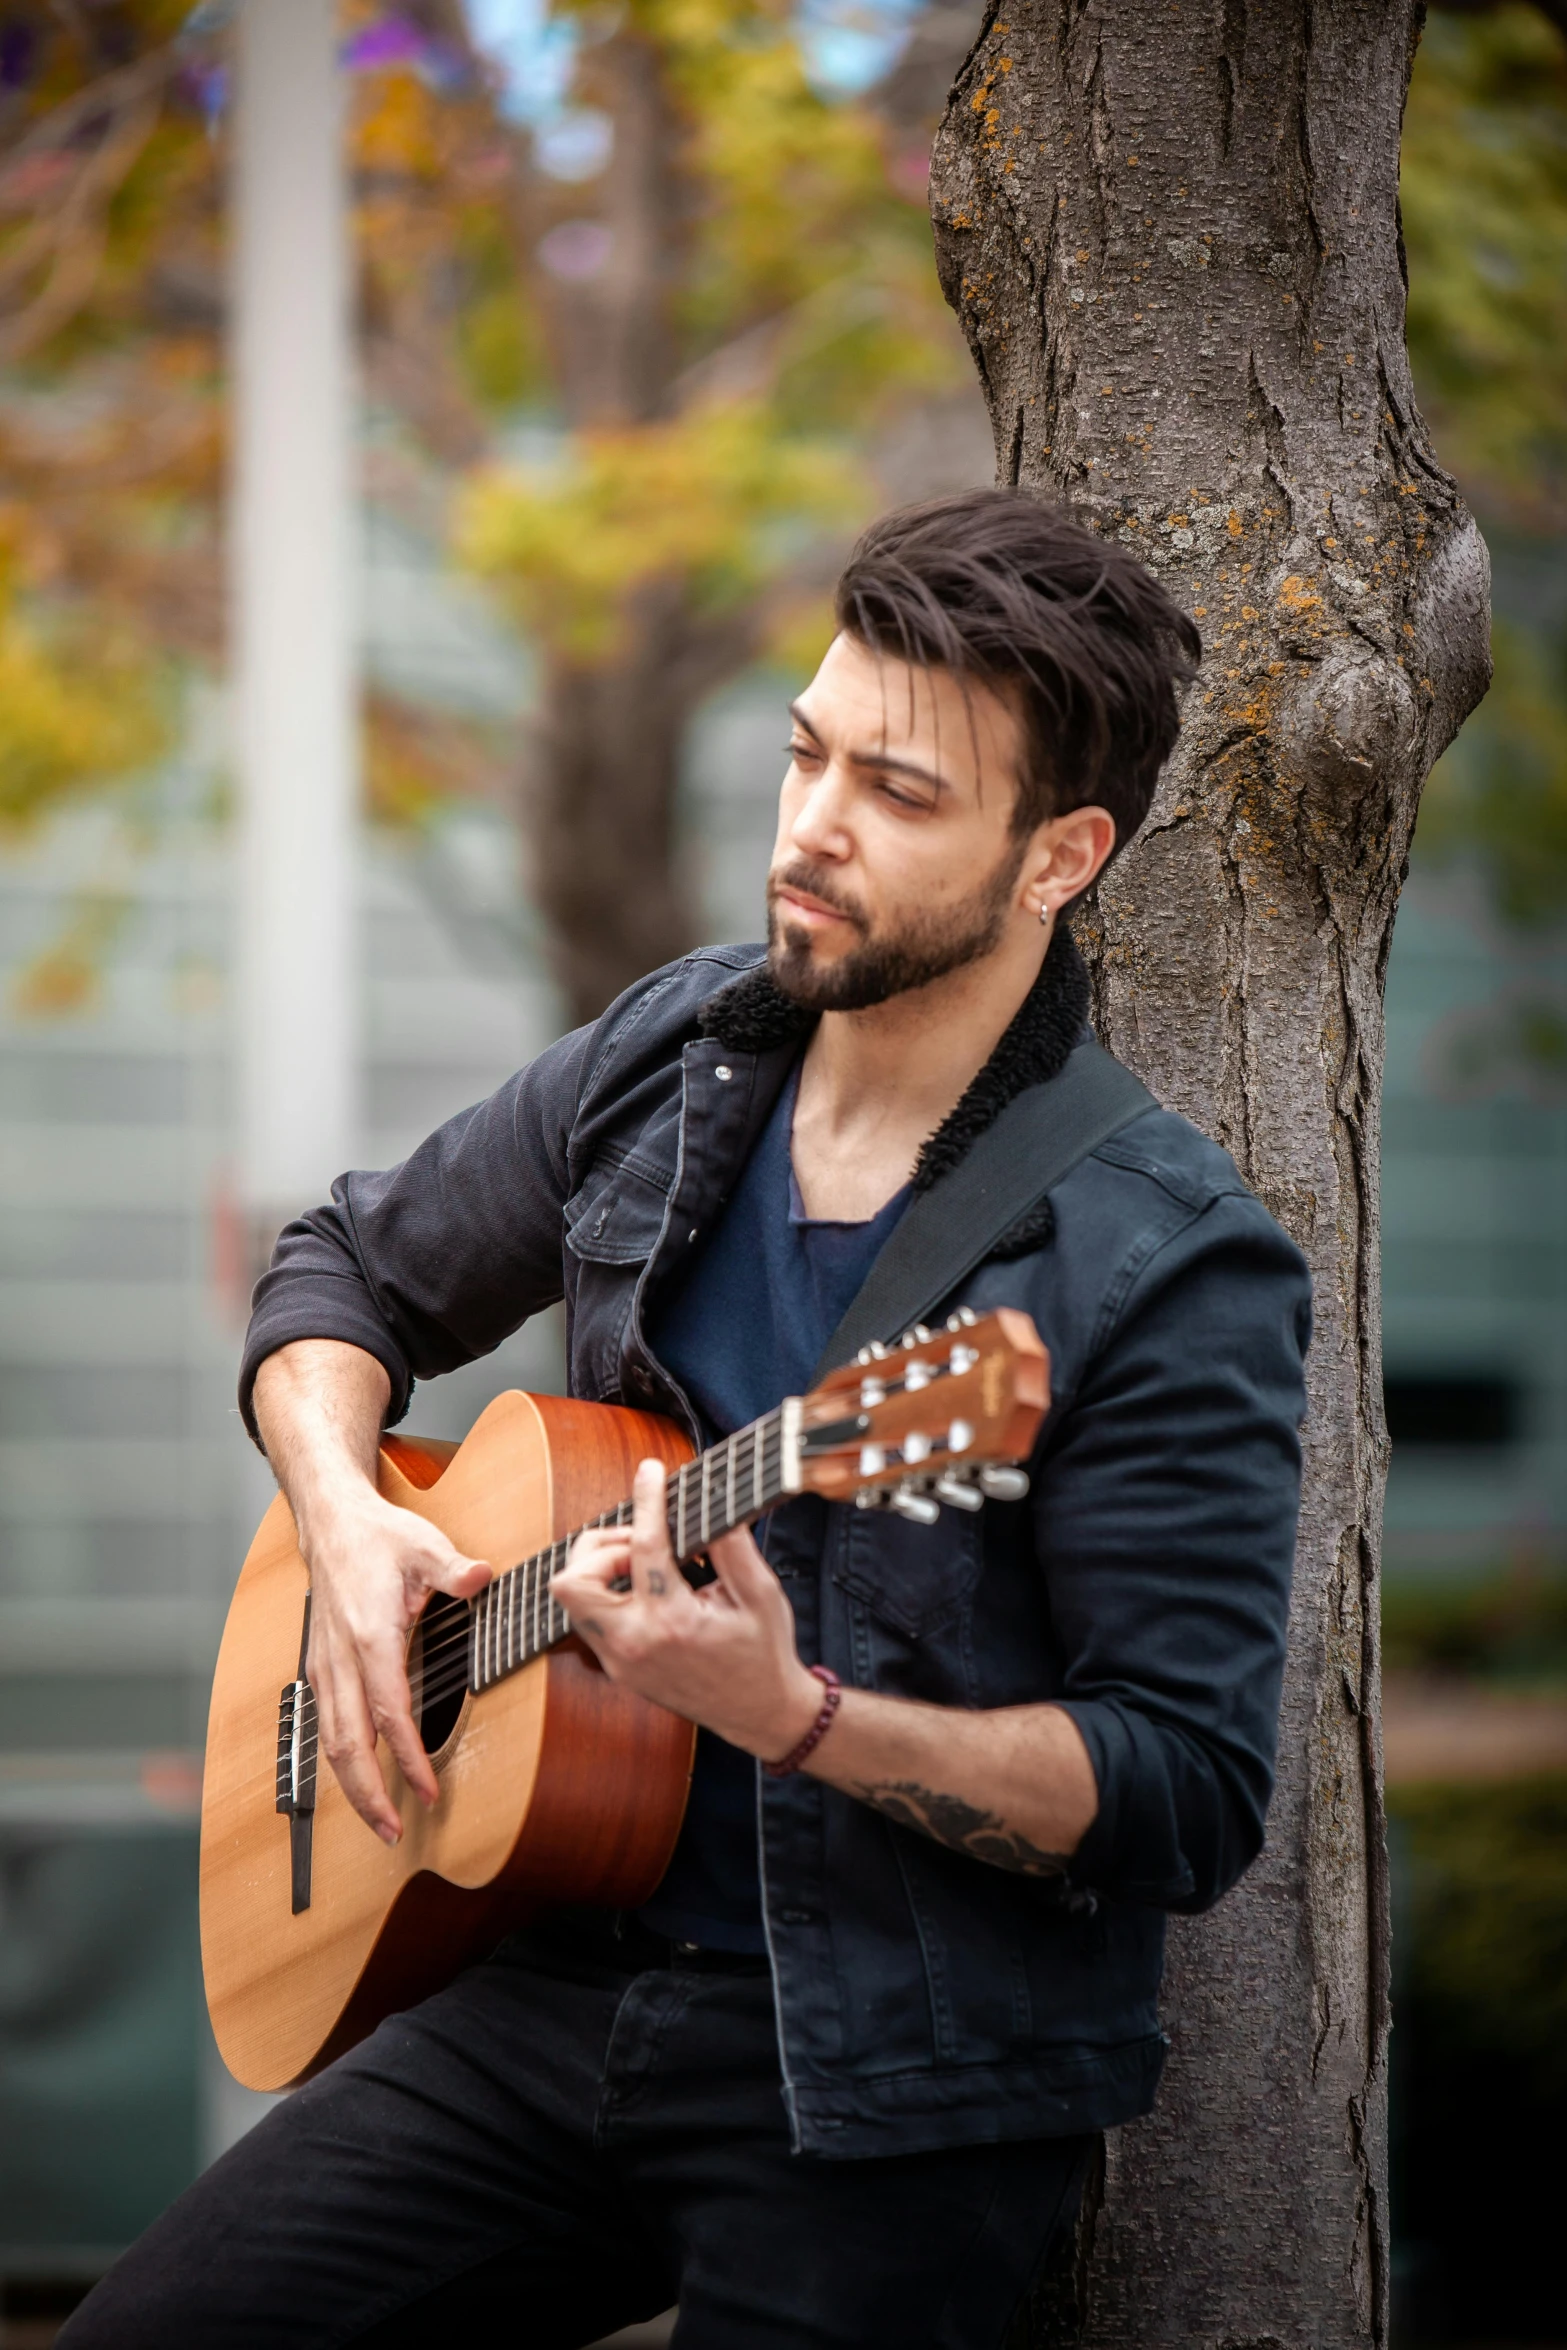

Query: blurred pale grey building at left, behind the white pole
[0,517,557,2277]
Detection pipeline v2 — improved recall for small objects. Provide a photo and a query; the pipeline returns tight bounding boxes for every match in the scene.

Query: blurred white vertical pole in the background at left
[233,0,357,1246]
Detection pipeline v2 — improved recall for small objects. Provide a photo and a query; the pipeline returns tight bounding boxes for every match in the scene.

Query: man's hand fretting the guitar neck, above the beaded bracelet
[552,1462,822,1763]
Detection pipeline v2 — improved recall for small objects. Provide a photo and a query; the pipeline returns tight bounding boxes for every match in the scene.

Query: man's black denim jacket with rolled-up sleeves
[240,933,1311,2155]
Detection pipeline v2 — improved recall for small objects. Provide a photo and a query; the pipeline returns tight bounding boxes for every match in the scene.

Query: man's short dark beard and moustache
[768,841,1027,1013]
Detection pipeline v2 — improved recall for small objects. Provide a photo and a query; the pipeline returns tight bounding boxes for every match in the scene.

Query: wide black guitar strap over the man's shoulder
[811,1036,1158,1387]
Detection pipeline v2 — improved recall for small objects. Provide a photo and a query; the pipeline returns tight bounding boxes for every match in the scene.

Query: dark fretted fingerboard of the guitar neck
[468,1398,801,1692]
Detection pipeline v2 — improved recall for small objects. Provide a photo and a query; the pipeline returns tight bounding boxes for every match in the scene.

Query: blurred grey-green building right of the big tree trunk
[1381,874,1567,1582]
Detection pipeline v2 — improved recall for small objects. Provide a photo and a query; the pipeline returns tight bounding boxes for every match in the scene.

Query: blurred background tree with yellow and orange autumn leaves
[0,0,973,1018]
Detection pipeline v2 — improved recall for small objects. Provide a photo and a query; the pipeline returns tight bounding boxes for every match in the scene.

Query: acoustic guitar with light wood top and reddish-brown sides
[202,1311,1048,2089]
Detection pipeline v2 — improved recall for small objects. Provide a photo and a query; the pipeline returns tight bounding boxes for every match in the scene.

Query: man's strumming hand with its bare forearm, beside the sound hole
[254,1337,491,1845]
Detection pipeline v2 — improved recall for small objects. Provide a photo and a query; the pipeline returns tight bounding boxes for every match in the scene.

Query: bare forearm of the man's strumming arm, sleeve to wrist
[256,1337,392,1551]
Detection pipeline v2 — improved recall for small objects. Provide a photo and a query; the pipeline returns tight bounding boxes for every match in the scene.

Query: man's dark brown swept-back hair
[836,489,1203,848]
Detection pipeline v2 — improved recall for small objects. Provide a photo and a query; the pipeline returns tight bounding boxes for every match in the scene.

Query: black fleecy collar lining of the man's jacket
[698,921,1088,1191]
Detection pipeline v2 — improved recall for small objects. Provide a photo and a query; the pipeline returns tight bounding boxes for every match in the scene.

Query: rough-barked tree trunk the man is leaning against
[933,0,1489,2350]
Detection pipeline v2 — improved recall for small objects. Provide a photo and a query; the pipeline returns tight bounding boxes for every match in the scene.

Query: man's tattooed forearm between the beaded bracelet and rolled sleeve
[806,1690,1099,1875]
